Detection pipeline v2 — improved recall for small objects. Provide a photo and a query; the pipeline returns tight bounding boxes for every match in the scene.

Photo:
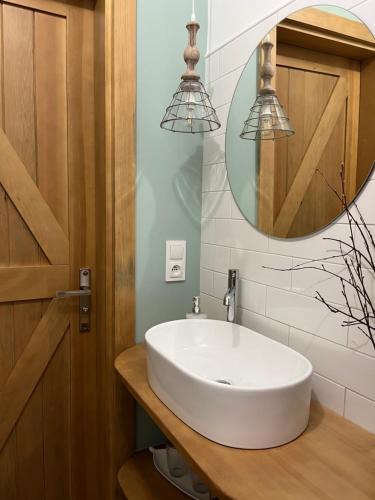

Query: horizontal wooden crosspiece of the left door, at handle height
[0,266,69,303]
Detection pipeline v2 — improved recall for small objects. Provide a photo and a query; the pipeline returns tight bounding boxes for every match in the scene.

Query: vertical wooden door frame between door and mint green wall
[95,0,136,499]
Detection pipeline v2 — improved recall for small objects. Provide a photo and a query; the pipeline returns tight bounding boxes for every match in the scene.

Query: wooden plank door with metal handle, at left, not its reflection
[0,0,97,500]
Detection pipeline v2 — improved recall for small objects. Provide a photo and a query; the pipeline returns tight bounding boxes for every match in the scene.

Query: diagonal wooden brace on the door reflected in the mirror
[273,77,348,237]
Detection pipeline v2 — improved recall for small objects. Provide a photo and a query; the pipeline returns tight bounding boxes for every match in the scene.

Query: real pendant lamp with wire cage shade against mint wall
[160,0,220,134]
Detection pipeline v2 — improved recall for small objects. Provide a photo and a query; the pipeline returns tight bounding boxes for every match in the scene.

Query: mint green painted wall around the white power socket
[136,0,207,448]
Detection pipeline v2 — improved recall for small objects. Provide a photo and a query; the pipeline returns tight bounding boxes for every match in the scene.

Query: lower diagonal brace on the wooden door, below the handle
[0,299,70,451]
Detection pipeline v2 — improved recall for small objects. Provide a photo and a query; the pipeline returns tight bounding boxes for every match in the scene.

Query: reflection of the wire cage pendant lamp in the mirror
[240,35,294,141]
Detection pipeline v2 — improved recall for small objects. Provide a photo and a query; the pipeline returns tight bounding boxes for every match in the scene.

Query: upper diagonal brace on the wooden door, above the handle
[0,130,69,264]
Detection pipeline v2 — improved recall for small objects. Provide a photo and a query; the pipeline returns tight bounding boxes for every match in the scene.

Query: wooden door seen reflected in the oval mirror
[262,43,360,237]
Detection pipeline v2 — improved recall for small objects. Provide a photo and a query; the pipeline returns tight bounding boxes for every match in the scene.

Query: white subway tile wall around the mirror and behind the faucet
[201,0,375,432]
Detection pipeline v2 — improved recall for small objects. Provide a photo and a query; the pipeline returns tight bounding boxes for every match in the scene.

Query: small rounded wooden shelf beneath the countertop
[118,451,189,500]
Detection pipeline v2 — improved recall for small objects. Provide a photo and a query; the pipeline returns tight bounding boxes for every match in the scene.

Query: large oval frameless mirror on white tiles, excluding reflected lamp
[226,6,375,238]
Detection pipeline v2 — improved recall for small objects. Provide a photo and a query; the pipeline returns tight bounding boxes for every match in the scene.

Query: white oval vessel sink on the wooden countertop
[146,319,312,449]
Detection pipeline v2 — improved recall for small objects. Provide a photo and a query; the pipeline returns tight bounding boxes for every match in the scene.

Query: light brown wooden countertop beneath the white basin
[115,345,375,500]
